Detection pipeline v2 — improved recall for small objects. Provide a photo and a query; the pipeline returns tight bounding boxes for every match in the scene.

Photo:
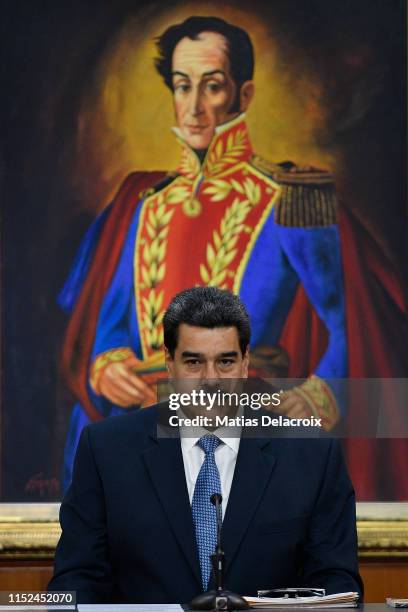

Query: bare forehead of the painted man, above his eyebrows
[172,32,229,74]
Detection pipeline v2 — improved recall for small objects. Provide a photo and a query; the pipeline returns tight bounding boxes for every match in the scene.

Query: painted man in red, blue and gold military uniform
[61,16,347,488]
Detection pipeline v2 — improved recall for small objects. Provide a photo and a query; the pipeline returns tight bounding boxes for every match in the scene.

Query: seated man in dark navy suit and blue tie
[49,287,363,603]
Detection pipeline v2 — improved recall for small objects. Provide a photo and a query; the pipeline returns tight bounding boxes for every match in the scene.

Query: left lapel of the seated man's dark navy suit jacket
[144,438,201,591]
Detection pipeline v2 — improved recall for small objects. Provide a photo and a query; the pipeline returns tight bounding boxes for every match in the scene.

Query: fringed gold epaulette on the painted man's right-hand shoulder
[251,155,337,227]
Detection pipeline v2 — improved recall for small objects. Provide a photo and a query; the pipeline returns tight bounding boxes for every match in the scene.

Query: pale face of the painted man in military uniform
[172,32,245,150]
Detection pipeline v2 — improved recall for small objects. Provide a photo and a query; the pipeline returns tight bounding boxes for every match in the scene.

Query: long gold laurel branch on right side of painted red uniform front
[200,198,254,289]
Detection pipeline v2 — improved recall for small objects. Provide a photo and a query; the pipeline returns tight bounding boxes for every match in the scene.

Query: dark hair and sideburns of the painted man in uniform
[155,16,254,101]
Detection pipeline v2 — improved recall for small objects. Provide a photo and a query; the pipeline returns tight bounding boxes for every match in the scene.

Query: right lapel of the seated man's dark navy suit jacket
[222,437,276,573]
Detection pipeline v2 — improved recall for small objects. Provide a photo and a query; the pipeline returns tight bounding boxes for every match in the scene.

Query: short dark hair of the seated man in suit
[163,287,251,357]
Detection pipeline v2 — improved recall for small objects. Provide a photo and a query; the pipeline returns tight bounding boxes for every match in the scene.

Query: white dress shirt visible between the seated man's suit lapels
[180,420,241,517]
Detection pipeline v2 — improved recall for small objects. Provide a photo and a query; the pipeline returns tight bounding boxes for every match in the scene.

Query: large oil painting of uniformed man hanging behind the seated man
[0,0,408,548]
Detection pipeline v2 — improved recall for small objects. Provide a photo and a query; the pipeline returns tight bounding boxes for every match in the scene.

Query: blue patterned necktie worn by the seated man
[191,435,222,591]
